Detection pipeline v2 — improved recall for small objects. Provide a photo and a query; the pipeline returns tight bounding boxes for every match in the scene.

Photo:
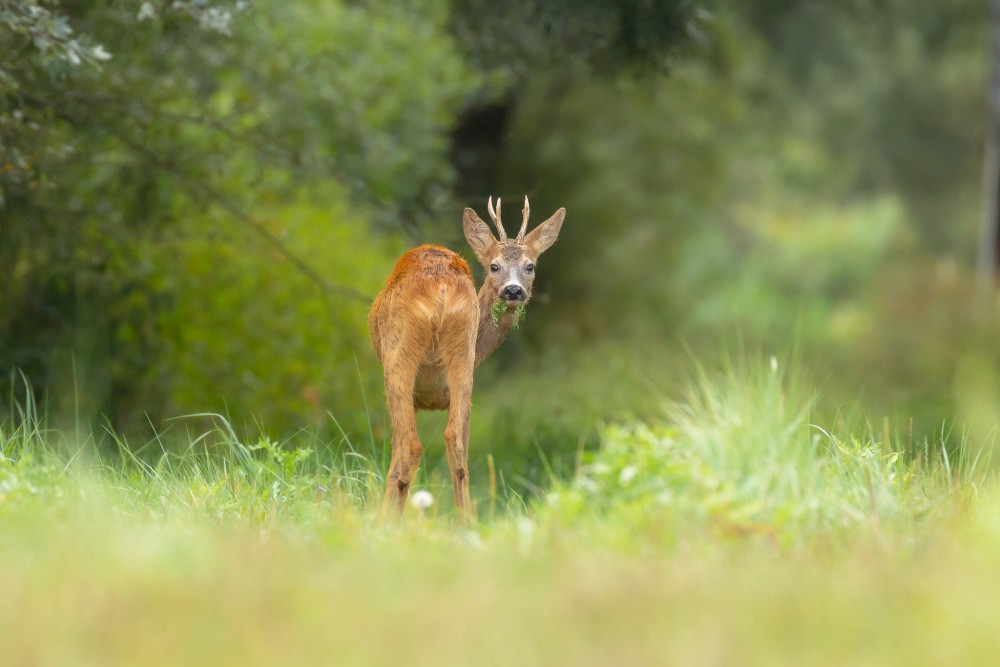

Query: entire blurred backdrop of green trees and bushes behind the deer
[0,0,1000,489]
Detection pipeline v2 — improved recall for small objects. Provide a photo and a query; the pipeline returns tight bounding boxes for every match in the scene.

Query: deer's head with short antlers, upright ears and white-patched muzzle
[462,196,566,308]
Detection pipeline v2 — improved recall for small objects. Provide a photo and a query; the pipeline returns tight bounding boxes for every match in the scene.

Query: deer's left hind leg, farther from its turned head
[382,338,424,515]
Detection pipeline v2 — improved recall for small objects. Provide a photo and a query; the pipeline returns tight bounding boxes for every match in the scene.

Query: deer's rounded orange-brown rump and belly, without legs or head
[369,245,479,410]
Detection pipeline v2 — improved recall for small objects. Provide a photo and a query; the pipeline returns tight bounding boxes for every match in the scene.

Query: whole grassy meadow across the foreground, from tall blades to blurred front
[0,352,1000,665]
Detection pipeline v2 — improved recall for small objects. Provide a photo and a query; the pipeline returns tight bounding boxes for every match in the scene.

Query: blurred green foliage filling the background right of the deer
[462,2,1000,451]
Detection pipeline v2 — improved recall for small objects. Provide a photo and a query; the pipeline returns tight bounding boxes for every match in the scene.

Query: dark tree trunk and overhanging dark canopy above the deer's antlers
[450,0,711,199]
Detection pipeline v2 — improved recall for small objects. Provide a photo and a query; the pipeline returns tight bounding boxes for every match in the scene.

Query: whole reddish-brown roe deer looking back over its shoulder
[368,197,566,520]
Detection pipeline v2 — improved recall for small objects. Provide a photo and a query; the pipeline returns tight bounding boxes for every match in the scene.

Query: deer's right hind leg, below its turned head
[444,331,475,521]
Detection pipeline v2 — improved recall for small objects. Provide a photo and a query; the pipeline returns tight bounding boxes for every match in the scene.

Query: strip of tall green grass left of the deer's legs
[0,398,382,527]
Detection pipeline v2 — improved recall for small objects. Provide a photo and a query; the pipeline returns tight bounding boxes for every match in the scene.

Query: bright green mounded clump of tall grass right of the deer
[550,357,960,548]
